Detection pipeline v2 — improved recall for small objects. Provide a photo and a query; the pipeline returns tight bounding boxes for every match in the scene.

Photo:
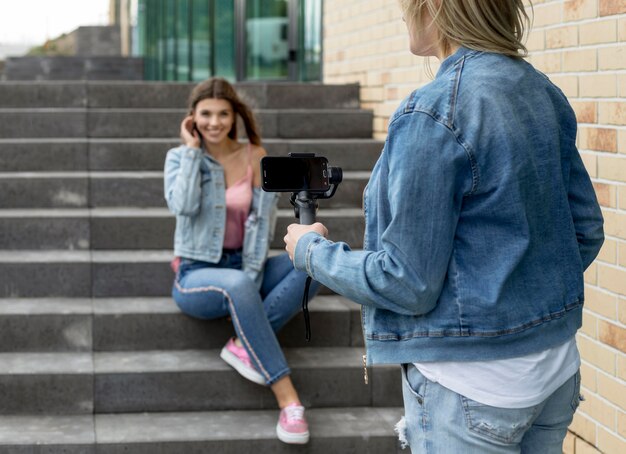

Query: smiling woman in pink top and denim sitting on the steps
[164,78,317,444]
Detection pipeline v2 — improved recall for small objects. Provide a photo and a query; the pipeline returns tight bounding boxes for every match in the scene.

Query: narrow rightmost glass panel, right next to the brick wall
[299,0,322,81]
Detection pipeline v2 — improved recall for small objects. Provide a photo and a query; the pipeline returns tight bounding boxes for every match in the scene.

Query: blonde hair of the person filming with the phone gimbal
[400,0,532,58]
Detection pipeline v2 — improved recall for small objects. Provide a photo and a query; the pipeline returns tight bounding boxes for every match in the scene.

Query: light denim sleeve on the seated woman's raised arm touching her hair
[164,146,202,216]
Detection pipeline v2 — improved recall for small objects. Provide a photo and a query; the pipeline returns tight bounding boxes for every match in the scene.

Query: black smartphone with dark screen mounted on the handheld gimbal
[261,156,330,192]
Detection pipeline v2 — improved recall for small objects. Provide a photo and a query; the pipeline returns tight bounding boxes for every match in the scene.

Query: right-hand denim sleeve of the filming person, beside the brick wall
[568,147,604,269]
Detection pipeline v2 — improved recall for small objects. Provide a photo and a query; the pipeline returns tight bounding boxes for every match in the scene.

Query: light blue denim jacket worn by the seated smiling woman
[164,146,277,287]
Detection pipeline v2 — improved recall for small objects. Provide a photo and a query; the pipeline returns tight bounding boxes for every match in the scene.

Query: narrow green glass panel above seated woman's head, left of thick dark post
[214,0,236,81]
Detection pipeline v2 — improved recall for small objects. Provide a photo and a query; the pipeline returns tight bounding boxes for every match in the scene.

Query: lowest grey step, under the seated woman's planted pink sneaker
[0,407,405,454]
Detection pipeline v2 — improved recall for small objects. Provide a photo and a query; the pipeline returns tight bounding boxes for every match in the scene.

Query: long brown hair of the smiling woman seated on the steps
[188,77,261,145]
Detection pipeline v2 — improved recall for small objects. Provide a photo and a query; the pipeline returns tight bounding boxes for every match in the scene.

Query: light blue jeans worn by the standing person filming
[402,364,580,454]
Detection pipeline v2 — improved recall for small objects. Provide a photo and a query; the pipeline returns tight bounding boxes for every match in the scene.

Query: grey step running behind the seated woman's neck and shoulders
[0,137,383,172]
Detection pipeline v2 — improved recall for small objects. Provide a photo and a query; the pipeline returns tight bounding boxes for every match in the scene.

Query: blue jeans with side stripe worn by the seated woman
[172,252,319,385]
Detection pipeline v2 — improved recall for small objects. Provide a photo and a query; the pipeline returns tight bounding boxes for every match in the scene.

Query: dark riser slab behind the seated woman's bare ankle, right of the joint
[95,366,401,413]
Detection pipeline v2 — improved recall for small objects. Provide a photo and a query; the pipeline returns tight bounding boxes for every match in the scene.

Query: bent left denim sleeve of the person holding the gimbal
[294,112,473,315]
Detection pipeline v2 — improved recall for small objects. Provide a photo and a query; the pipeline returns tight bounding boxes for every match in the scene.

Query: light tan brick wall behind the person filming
[324,0,626,454]
